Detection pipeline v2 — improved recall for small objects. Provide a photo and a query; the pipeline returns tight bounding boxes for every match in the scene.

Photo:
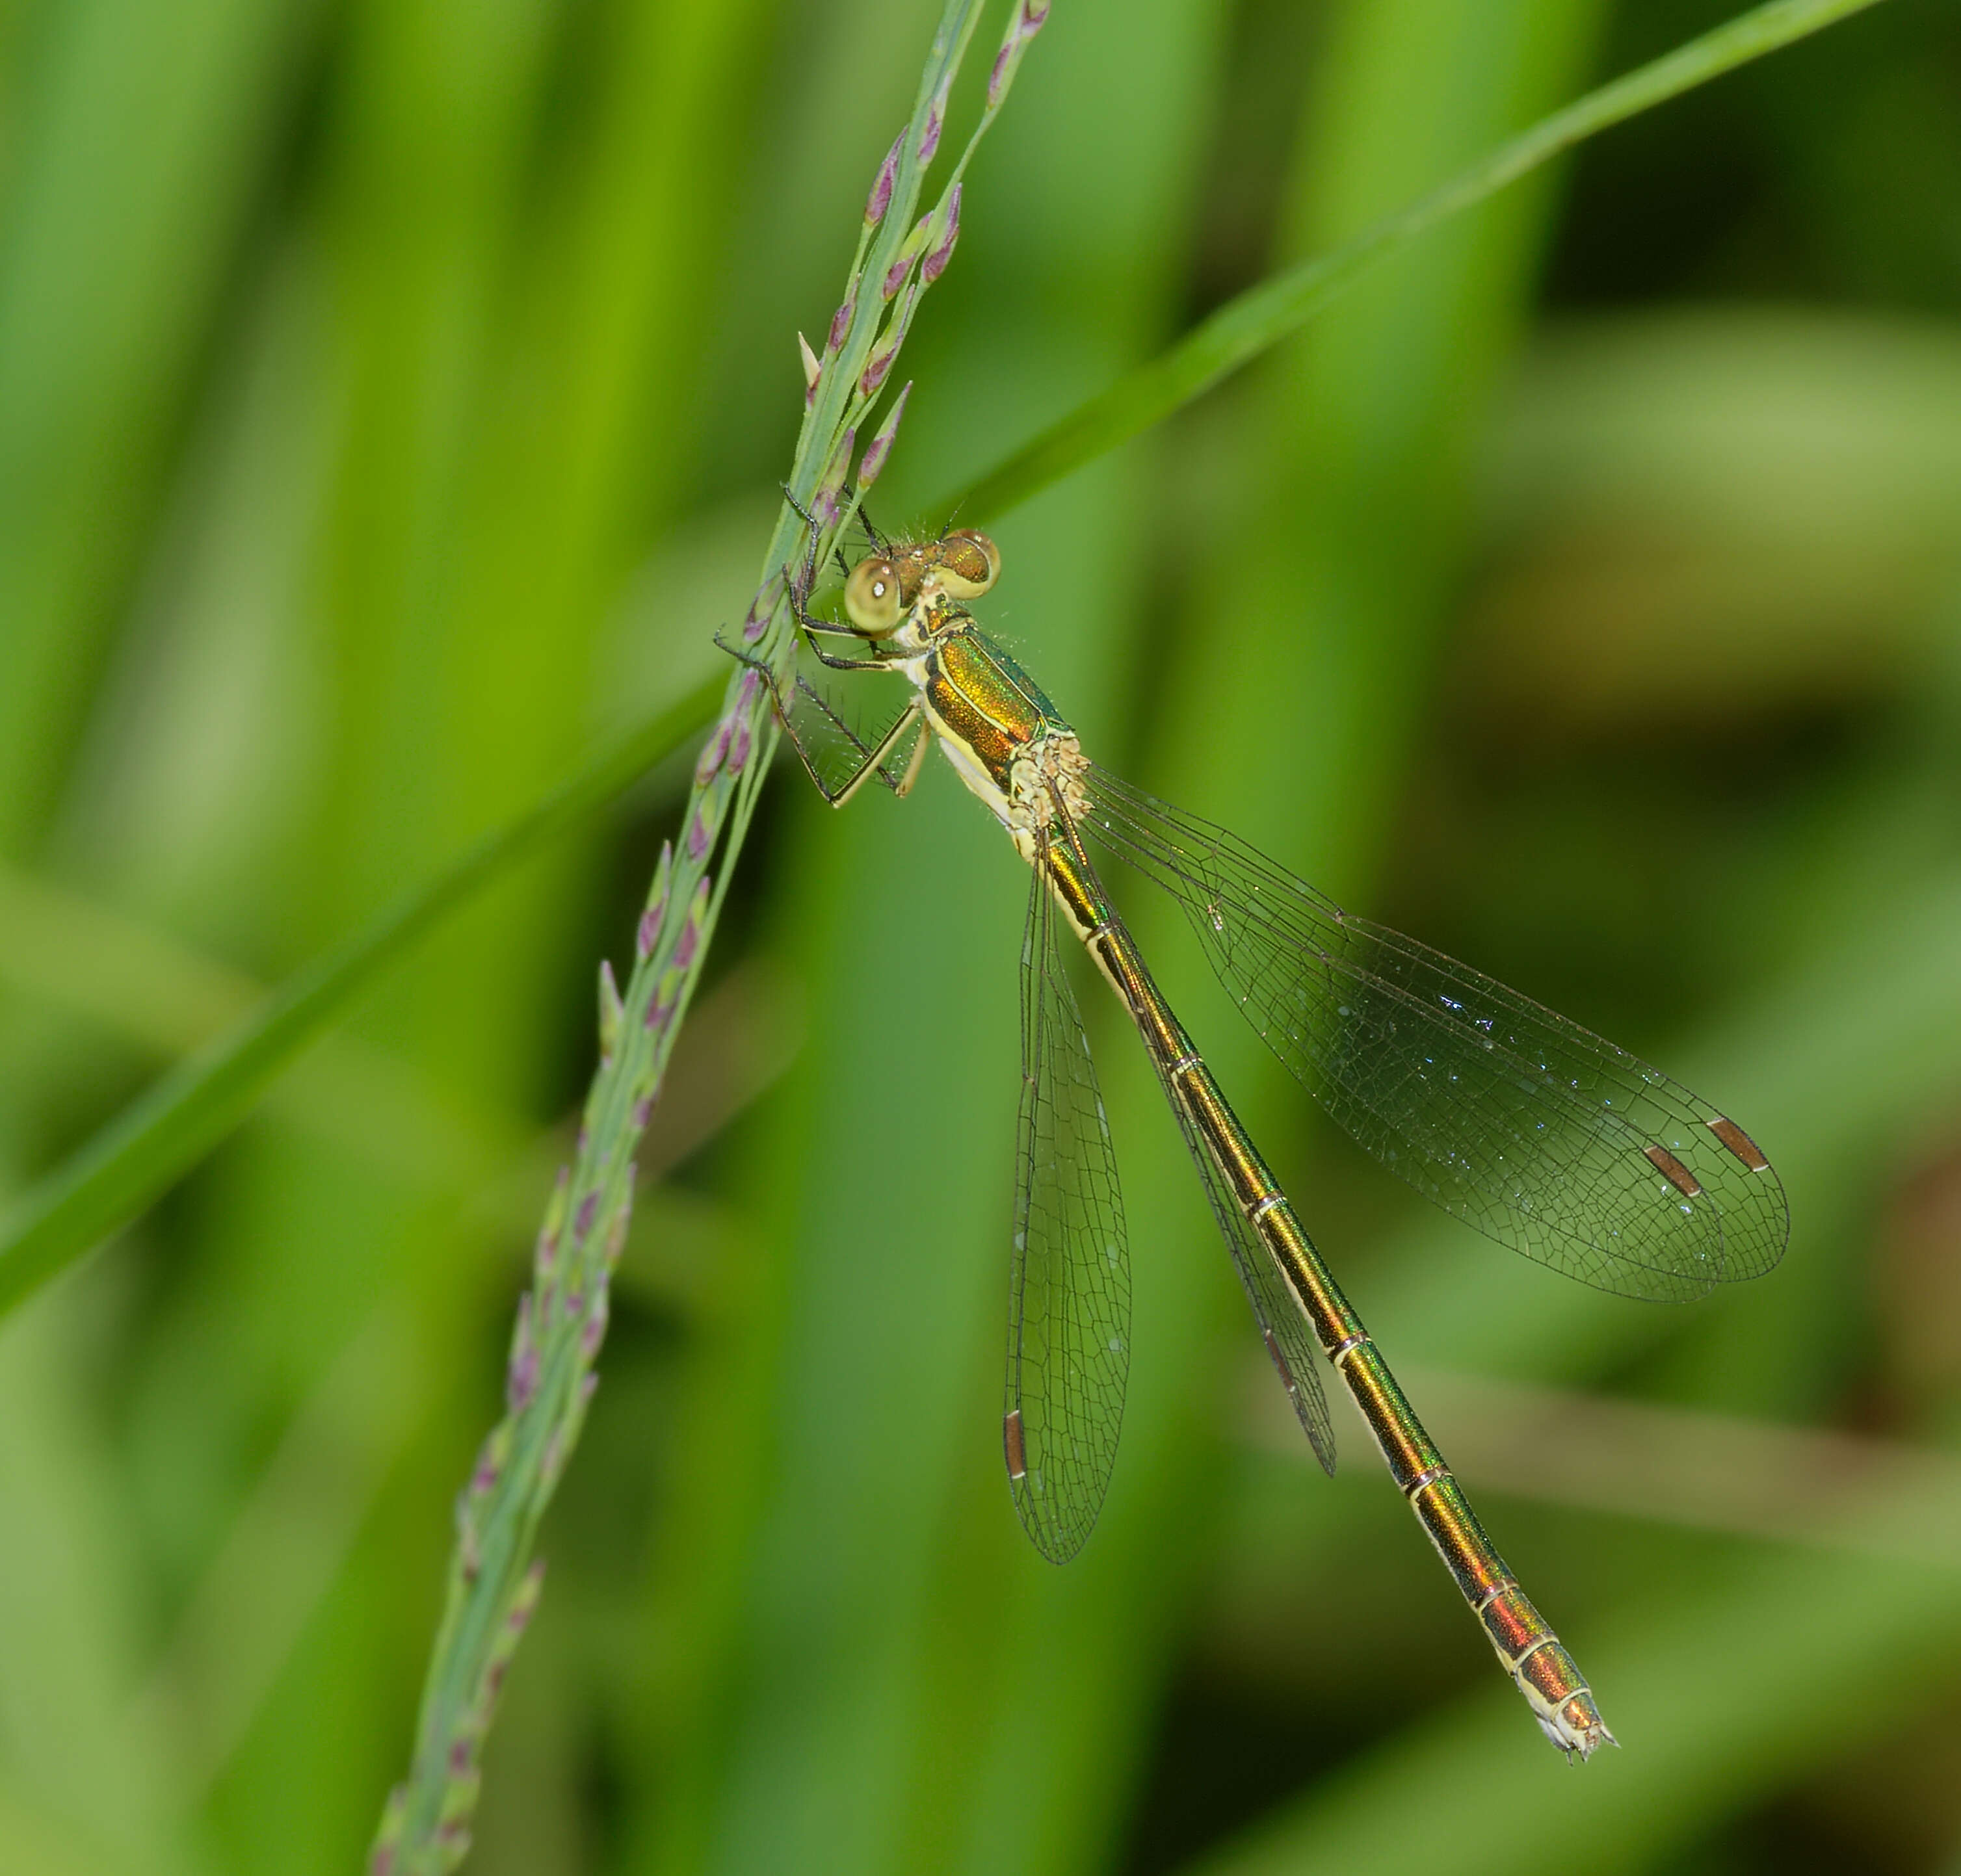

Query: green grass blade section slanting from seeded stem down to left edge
[0,676,722,1316]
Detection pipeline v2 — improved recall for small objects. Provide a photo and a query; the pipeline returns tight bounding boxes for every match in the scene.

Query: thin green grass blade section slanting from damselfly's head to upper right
[956,0,1878,523]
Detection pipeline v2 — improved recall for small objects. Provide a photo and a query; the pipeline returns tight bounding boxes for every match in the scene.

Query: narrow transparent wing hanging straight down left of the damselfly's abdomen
[1002,842,1129,1562]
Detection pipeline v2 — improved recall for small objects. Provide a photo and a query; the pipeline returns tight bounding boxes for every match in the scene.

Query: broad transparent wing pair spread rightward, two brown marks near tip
[1079,768,1789,1301]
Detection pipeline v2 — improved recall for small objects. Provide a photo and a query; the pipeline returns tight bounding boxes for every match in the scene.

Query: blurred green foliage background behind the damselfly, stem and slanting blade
[0,0,1961,1876]
